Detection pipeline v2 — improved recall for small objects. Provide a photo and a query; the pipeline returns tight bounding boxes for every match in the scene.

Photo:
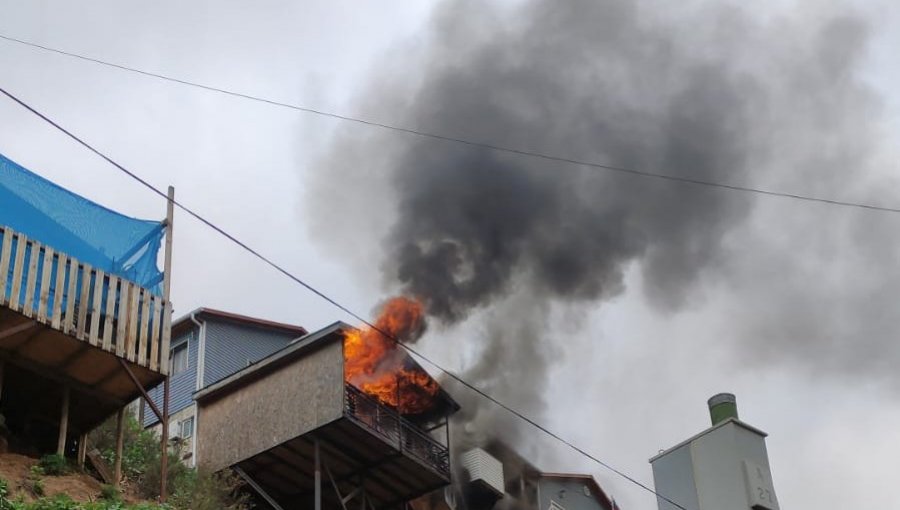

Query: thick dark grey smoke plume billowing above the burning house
[304,0,876,450]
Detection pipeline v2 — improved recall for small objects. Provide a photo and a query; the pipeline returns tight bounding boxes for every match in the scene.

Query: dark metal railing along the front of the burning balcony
[344,384,450,478]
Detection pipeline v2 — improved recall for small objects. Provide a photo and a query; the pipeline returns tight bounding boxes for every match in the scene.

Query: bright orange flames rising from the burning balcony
[344,297,439,414]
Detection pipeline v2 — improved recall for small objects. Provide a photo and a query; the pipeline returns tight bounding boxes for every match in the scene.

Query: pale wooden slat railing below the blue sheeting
[0,226,172,374]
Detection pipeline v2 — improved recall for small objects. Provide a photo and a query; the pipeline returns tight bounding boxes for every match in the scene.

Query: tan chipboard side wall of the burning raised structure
[197,339,344,471]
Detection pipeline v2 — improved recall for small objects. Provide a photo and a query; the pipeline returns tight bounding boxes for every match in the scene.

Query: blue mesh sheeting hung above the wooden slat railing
[0,154,165,295]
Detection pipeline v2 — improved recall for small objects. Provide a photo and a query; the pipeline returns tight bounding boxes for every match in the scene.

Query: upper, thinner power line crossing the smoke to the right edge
[0,34,900,213]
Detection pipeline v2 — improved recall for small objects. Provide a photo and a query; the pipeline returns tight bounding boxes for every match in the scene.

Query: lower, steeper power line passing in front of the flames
[0,84,688,510]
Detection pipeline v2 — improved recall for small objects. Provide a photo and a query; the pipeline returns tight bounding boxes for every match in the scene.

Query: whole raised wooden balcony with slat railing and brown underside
[0,226,171,440]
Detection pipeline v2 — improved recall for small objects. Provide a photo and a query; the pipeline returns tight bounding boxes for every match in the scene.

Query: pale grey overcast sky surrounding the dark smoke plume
[0,0,900,510]
